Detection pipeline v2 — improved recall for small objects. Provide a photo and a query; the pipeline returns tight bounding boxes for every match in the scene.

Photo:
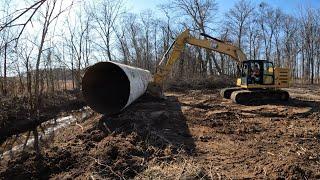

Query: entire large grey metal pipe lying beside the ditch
[82,61,152,115]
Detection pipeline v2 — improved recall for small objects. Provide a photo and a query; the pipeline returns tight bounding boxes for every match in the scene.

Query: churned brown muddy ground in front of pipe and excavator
[0,87,320,179]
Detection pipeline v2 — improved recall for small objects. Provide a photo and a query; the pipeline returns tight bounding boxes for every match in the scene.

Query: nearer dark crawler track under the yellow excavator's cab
[230,89,290,105]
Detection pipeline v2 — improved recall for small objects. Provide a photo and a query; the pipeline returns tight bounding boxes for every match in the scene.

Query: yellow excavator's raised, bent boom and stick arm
[149,29,246,96]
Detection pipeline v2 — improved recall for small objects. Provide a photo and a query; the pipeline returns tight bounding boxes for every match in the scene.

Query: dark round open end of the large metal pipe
[82,62,130,115]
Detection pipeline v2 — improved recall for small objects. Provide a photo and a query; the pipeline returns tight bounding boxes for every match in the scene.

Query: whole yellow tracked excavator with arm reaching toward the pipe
[148,29,290,104]
